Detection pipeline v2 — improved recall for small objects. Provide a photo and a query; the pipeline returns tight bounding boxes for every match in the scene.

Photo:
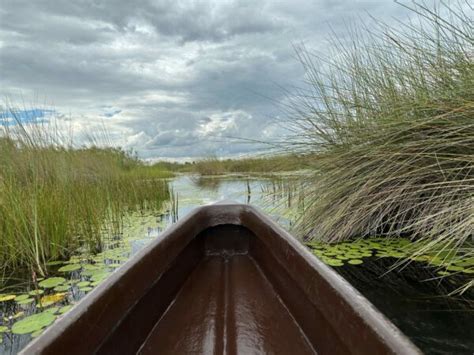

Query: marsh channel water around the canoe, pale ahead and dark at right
[0,175,474,354]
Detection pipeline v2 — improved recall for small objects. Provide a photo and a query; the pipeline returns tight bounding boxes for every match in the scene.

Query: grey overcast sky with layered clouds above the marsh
[0,0,408,159]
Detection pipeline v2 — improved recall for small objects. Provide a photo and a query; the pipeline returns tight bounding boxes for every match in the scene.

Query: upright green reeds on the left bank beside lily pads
[0,111,169,273]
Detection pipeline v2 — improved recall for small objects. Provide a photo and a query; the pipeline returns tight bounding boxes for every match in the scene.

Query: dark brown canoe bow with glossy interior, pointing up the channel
[23,203,420,355]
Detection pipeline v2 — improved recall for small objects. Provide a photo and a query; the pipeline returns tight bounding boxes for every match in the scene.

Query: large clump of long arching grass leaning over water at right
[290,1,474,270]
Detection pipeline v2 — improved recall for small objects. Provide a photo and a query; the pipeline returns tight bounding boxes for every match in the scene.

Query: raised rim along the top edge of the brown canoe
[20,202,421,354]
